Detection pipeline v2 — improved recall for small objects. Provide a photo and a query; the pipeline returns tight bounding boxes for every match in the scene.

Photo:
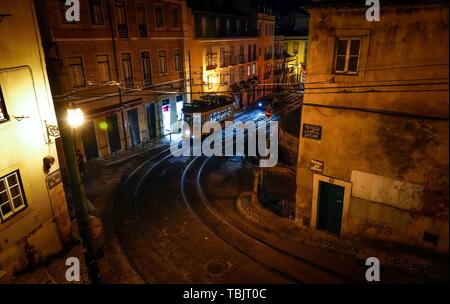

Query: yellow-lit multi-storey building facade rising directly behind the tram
[185,4,275,109]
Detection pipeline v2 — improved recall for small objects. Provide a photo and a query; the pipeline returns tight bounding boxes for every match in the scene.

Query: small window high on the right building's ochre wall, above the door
[334,39,361,74]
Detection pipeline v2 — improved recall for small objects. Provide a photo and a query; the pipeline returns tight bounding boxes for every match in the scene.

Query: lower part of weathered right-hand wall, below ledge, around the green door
[297,107,448,251]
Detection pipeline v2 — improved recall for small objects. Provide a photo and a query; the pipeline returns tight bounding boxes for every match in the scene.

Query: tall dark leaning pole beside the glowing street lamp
[35,0,100,283]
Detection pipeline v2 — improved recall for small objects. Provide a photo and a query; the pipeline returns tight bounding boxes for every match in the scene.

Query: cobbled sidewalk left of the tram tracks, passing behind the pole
[11,140,166,284]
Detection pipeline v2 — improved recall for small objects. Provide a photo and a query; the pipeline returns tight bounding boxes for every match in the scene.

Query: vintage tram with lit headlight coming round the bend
[183,95,234,138]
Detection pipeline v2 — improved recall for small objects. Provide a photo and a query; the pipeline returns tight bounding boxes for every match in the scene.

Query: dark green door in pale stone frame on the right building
[317,182,345,235]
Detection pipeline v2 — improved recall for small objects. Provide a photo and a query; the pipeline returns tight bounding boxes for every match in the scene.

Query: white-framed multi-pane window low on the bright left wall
[0,170,27,221]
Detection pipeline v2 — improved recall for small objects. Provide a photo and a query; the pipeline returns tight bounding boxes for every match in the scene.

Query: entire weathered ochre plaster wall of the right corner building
[296,4,448,252]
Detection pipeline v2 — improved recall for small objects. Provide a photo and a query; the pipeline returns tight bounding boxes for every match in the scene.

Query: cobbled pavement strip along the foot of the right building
[236,192,448,281]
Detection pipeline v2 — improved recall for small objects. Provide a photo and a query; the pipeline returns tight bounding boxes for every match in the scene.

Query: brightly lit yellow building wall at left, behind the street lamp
[0,0,70,274]
